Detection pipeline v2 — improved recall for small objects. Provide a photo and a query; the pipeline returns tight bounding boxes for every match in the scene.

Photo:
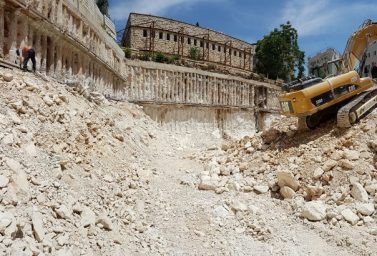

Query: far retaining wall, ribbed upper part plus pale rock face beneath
[98,60,280,135]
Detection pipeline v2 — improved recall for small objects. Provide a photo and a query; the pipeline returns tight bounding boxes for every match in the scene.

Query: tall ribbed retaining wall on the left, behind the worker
[0,0,124,90]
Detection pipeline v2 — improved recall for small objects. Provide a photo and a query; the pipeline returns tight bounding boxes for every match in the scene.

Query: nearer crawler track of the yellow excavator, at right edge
[337,86,377,128]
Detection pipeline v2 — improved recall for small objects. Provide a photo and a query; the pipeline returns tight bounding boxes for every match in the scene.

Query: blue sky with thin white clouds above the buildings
[109,0,377,62]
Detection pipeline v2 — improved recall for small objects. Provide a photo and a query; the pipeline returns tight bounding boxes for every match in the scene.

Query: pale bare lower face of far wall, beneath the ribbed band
[143,104,256,144]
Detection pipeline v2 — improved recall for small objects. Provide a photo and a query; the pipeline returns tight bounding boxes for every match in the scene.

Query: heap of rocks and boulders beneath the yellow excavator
[196,111,377,230]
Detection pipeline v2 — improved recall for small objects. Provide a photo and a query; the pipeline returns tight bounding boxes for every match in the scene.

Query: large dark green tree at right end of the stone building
[256,21,305,81]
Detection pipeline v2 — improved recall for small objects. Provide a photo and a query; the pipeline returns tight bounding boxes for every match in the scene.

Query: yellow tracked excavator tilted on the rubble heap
[279,20,377,129]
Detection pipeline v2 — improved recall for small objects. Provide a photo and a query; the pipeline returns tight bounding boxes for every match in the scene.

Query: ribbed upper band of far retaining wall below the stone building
[104,60,280,111]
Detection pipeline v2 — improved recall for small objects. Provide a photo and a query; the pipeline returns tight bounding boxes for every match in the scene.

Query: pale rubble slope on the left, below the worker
[0,69,156,255]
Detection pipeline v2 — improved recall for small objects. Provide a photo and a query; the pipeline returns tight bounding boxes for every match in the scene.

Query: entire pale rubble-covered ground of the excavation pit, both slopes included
[0,69,377,255]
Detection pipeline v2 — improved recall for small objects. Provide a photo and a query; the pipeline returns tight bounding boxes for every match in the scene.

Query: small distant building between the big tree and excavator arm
[308,48,341,78]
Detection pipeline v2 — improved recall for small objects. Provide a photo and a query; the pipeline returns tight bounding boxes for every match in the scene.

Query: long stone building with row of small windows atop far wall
[121,13,255,72]
